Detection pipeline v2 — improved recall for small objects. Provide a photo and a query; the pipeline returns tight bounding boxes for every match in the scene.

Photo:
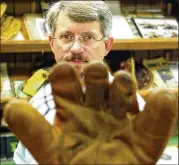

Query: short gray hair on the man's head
[46,1,112,37]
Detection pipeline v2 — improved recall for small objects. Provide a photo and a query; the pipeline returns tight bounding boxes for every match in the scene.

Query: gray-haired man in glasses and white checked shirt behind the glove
[14,1,119,164]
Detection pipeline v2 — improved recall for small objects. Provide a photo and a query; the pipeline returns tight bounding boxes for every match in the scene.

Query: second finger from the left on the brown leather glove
[49,63,83,120]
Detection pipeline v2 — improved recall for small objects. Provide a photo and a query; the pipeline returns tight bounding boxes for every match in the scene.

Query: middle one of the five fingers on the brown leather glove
[84,62,109,110]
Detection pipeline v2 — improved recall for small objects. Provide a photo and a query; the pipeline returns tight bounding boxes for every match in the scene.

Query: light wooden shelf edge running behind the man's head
[1,38,178,53]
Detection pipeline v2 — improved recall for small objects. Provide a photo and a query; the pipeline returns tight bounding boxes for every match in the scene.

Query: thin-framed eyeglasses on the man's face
[52,34,105,47]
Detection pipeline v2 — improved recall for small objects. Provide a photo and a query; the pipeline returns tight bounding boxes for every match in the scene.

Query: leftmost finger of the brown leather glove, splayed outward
[3,99,61,164]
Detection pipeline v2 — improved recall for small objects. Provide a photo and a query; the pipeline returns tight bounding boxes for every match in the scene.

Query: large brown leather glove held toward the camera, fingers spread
[3,63,177,164]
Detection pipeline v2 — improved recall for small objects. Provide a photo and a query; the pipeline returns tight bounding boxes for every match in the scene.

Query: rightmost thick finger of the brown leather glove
[134,89,178,161]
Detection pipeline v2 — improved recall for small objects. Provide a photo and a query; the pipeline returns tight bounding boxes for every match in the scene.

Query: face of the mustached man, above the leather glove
[49,12,113,75]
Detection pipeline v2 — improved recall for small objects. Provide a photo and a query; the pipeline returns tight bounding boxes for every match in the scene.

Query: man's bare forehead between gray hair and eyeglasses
[55,11,102,34]
